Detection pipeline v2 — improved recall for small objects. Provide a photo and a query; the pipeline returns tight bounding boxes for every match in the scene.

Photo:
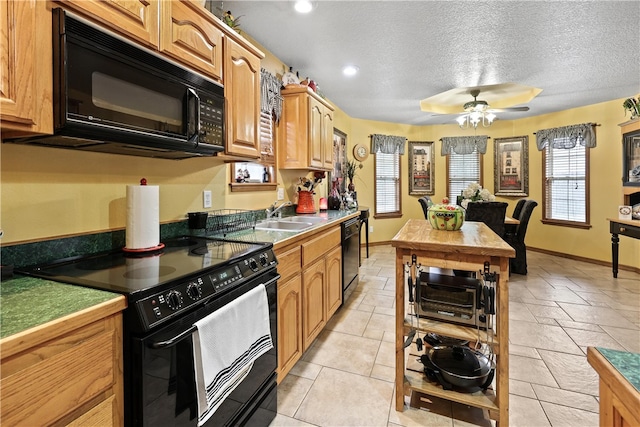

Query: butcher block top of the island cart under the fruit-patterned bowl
[391,219,516,258]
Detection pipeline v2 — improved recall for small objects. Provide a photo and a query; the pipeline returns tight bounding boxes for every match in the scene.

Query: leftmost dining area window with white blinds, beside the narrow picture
[375,152,402,217]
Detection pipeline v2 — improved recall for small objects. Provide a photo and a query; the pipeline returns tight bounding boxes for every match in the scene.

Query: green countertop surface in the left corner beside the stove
[0,275,119,338]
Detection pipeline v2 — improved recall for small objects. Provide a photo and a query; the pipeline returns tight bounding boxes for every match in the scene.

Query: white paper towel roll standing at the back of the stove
[126,185,160,249]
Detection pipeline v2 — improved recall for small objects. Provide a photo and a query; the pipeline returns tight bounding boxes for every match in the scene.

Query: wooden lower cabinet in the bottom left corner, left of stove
[0,297,125,426]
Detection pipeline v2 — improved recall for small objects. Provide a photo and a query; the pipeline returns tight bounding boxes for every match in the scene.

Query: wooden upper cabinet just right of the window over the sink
[278,86,333,170]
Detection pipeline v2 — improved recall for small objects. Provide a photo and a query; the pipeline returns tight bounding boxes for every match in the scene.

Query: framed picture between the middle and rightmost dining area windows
[493,136,529,197]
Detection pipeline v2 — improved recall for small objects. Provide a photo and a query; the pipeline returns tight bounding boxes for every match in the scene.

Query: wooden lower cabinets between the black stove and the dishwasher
[275,224,342,382]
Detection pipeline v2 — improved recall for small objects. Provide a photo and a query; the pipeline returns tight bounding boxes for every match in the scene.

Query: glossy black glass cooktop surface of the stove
[23,236,269,294]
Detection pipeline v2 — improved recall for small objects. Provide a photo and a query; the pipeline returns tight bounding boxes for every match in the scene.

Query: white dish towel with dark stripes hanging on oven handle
[193,285,273,426]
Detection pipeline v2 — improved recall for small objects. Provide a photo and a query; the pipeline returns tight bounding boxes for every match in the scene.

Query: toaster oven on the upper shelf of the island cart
[416,272,487,328]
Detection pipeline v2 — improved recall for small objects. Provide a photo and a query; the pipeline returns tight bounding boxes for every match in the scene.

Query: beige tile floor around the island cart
[271,246,640,427]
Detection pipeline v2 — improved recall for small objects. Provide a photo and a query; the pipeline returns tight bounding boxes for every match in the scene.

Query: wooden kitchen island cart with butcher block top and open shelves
[391,219,515,426]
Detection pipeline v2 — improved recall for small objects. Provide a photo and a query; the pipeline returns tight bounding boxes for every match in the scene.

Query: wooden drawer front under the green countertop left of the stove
[0,320,116,426]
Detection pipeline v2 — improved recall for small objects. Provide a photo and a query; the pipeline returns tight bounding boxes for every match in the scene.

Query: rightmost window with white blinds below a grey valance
[542,138,589,227]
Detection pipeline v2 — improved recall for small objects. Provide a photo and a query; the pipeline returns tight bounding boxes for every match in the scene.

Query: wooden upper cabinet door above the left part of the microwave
[56,0,159,50]
